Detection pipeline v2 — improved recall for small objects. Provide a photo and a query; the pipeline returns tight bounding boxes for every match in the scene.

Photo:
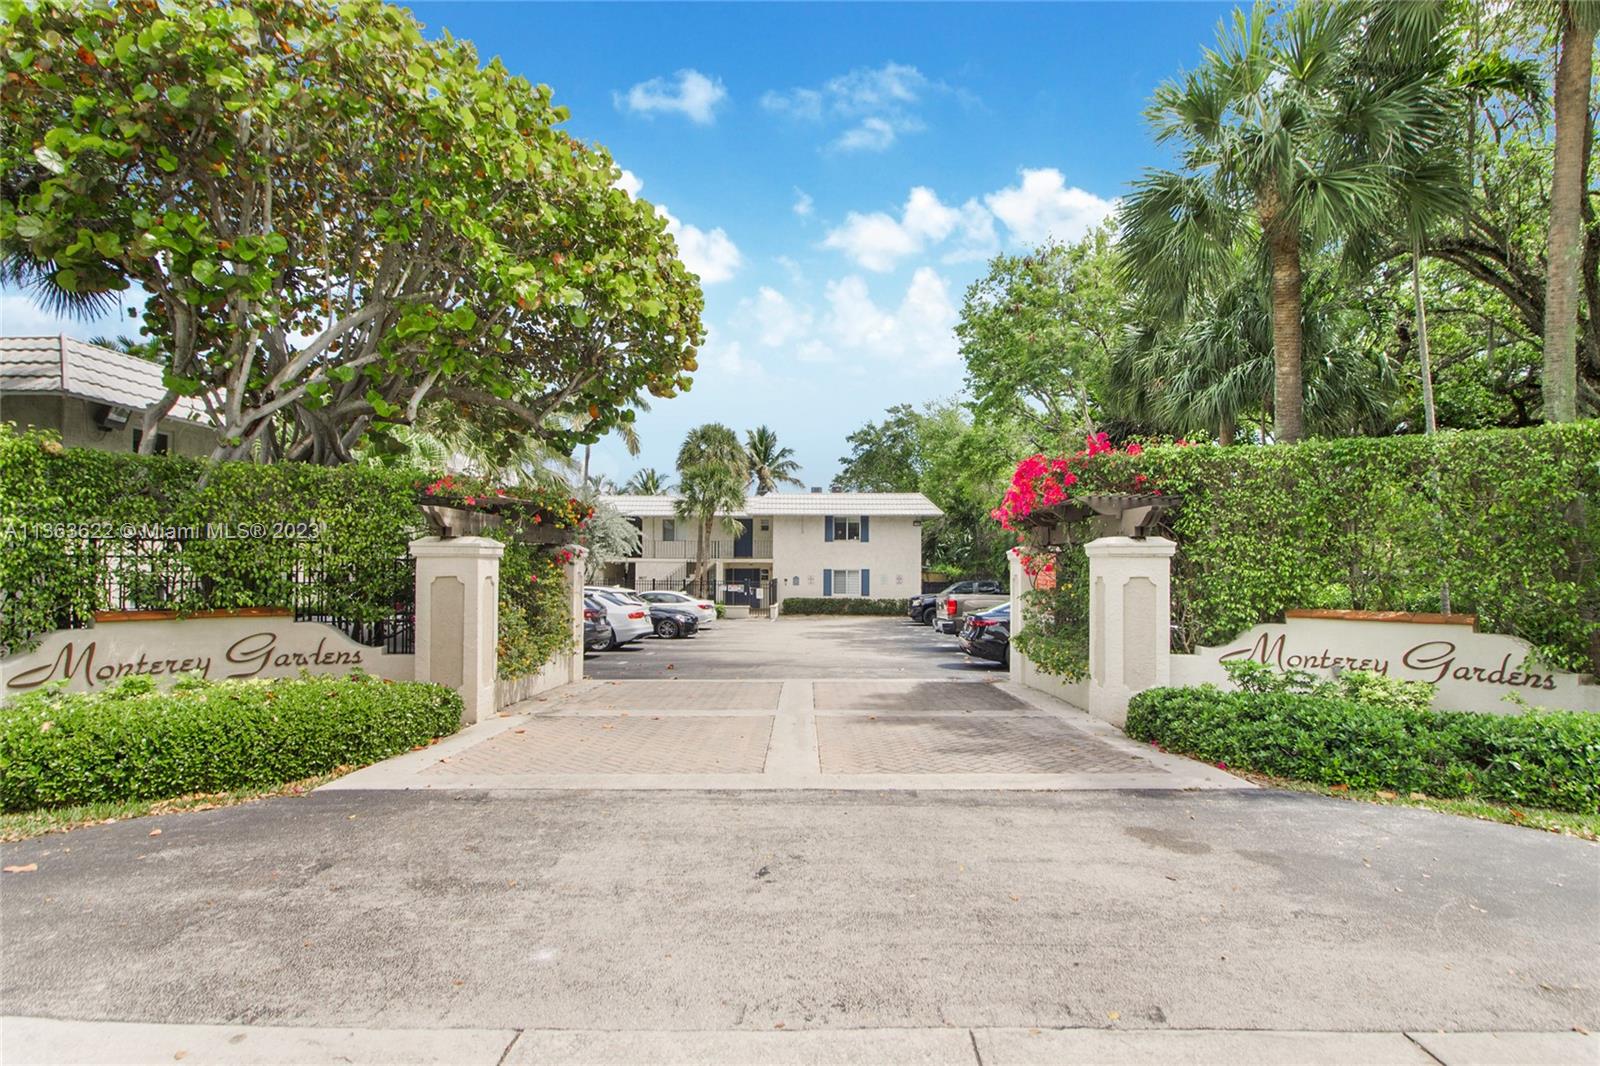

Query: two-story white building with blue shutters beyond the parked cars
[606,491,942,607]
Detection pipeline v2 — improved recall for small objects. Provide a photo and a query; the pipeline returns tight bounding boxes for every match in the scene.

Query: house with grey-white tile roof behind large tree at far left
[0,335,216,455]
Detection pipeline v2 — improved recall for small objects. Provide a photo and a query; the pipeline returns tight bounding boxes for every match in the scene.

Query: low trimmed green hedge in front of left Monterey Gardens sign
[0,675,461,812]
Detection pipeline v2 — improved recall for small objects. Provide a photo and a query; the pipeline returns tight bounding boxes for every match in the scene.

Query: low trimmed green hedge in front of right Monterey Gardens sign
[1126,685,1600,815]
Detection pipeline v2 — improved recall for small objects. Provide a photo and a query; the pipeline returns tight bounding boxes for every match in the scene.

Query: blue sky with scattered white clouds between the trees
[0,3,1230,483]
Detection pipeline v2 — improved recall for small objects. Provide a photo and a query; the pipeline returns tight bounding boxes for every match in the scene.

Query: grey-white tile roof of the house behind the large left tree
[0,335,211,423]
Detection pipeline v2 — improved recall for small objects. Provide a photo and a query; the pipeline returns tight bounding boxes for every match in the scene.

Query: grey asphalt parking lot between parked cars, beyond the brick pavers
[584,616,1005,680]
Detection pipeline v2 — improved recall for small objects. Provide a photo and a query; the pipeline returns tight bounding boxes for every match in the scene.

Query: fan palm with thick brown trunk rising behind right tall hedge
[1122,0,1446,440]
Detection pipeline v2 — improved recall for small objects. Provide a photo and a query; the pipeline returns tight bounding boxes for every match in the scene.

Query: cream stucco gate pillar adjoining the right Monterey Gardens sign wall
[1083,536,1178,728]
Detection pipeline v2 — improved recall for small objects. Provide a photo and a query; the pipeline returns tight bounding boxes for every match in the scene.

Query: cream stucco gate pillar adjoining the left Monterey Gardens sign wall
[411,536,502,723]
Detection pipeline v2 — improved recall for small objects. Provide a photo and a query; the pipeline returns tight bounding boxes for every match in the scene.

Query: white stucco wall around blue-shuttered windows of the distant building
[773,515,922,600]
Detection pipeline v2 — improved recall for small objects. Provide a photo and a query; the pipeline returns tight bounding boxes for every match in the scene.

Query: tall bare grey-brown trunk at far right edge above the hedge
[1544,0,1595,423]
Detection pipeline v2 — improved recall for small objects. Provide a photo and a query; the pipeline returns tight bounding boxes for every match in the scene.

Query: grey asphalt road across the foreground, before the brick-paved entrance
[0,791,1600,1031]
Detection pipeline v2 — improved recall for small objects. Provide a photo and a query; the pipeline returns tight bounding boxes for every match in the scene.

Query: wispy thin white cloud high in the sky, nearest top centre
[762,62,954,152]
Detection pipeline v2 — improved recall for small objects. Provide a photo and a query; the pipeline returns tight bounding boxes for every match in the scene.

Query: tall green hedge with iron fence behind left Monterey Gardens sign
[0,424,424,650]
